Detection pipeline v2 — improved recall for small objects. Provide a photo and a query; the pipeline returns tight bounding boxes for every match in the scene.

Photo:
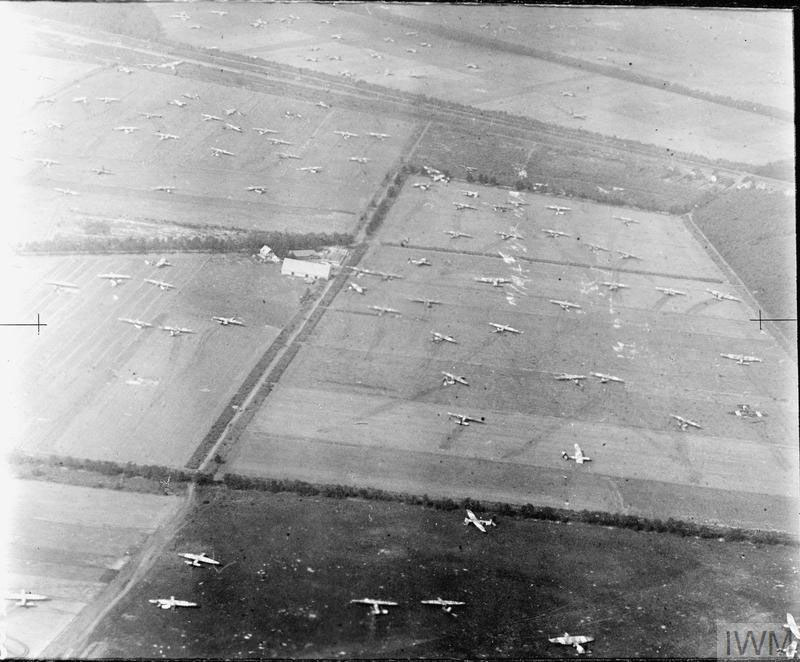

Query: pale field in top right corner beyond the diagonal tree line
[380,5,793,111]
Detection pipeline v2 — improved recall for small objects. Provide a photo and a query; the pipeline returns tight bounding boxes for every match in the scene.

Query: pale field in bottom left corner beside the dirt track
[2,480,179,658]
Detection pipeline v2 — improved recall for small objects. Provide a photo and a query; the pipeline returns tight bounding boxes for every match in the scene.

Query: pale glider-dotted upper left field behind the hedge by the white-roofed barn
[9,46,413,240]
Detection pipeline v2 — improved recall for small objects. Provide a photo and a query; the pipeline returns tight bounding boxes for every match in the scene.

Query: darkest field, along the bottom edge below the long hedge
[87,490,798,658]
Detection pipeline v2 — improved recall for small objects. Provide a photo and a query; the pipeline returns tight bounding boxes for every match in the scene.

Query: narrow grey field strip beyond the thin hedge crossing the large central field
[378,178,722,283]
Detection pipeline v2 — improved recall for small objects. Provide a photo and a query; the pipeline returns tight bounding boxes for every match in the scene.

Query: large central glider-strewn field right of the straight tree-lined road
[229,181,798,531]
